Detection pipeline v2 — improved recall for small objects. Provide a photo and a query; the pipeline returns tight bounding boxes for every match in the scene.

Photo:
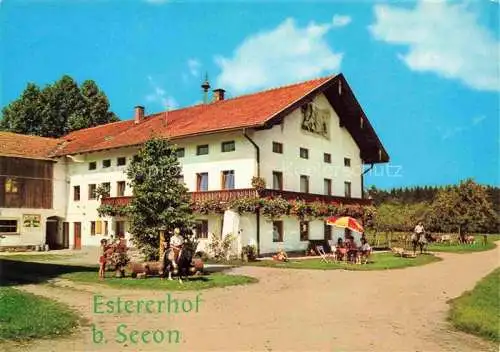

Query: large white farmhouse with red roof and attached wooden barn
[0,74,389,253]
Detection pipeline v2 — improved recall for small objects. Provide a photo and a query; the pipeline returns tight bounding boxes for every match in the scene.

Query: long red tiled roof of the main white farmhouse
[50,76,334,155]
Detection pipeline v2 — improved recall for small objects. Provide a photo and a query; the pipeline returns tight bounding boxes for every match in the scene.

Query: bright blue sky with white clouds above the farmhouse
[0,0,500,188]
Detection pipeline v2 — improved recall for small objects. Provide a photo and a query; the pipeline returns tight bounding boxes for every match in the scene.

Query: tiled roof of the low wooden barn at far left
[0,132,60,159]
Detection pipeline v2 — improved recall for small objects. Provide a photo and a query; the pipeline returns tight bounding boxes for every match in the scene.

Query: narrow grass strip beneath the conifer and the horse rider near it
[61,272,258,291]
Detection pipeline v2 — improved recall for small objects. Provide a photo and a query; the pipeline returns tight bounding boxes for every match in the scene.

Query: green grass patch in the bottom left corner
[0,287,80,341]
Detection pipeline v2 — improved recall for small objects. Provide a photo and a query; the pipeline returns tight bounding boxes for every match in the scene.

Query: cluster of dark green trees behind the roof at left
[0,75,118,137]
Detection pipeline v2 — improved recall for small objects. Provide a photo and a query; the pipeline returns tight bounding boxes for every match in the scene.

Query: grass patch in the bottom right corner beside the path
[449,268,500,342]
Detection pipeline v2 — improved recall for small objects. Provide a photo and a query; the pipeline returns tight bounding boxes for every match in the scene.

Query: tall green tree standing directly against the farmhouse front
[127,138,193,260]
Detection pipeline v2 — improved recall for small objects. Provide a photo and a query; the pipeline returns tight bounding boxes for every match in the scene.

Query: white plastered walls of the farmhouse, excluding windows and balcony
[0,95,372,253]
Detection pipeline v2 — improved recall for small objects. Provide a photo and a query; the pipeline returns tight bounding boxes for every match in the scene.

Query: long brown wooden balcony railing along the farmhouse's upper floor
[101,188,372,206]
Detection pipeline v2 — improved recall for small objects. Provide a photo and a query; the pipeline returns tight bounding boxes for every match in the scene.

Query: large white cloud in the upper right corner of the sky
[369,1,500,91]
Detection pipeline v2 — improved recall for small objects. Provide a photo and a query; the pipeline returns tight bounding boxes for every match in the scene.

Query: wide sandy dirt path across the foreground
[4,247,500,352]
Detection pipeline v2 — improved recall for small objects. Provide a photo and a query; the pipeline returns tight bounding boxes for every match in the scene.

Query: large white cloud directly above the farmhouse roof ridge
[215,18,342,94]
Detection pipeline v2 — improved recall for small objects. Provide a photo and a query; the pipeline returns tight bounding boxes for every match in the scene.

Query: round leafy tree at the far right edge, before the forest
[430,179,498,235]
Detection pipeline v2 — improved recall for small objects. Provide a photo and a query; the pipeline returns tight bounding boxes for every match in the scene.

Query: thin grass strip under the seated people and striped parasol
[247,253,441,271]
